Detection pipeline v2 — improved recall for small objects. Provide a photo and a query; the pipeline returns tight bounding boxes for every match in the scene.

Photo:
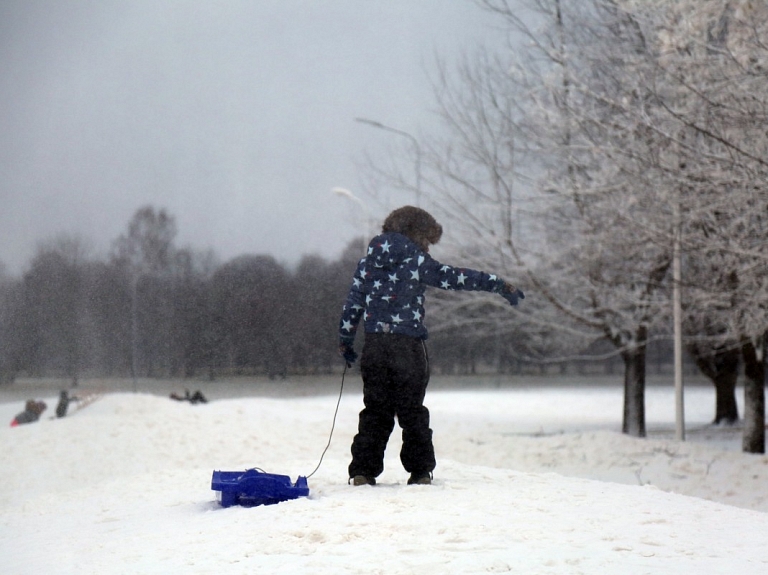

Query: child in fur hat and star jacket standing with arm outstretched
[339,206,525,485]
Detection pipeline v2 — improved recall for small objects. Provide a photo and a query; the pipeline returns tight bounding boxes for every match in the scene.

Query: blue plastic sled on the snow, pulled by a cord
[211,469,309,507]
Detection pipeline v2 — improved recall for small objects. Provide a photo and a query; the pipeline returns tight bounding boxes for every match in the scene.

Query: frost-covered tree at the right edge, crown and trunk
[620,0,768,453]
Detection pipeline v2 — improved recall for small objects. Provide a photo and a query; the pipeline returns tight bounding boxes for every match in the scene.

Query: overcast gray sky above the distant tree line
[0,0,500,274]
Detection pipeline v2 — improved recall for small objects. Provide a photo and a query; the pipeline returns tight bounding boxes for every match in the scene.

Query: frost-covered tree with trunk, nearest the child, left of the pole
[414,0,671,436]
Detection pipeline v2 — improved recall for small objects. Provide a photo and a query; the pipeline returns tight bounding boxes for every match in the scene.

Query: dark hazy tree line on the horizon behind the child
[0,206,584,385]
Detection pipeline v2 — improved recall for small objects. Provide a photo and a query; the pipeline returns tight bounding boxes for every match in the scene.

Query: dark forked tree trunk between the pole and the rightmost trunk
[688,345,741,425]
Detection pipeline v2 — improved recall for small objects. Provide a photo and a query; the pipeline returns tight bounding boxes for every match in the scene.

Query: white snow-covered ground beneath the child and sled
[0,378,768,575]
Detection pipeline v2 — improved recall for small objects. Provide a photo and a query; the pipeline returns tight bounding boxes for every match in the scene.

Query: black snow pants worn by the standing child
[349,333,435,477]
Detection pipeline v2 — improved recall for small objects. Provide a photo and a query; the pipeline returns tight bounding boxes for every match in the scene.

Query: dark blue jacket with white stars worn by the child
[339,232,504,341]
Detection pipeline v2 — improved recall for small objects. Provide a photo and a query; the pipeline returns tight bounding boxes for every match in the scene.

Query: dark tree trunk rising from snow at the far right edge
[741,336,765,453]
